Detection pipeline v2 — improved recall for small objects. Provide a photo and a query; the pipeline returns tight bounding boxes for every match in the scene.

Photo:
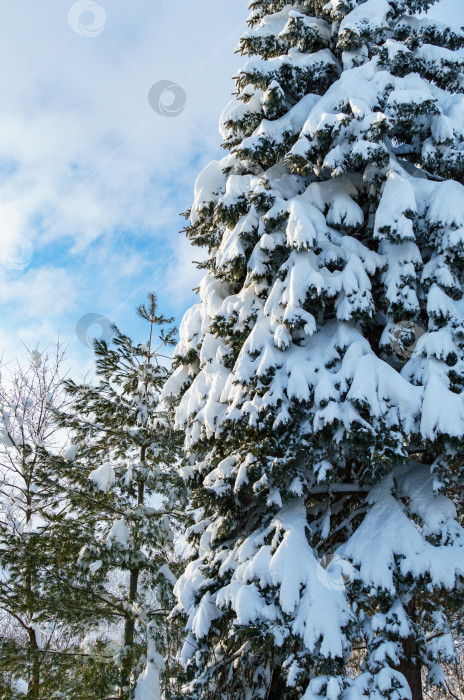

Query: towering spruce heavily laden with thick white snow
[166,0,464,700]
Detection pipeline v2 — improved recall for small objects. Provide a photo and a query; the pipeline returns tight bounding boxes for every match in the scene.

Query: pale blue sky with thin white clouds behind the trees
[0,0,464,369]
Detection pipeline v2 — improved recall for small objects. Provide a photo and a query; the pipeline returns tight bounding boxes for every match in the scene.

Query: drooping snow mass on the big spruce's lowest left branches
[176,499,349,657]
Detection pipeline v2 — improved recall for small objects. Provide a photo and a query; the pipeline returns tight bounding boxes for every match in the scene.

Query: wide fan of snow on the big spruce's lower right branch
[338,464,464,594]
